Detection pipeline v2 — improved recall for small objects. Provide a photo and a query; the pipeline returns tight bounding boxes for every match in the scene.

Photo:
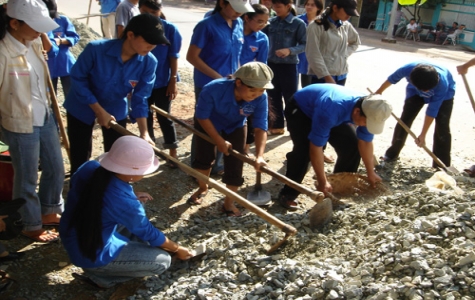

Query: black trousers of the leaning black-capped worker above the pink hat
[66,113,127,175]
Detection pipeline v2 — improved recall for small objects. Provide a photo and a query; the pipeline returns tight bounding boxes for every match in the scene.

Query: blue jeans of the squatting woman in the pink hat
[83,241,171,288]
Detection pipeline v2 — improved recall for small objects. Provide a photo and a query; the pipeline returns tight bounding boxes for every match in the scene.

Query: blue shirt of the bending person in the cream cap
[294,83,374,147]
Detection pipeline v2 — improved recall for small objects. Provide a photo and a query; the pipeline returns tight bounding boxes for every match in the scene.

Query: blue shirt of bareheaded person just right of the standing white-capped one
[240,31,269,66]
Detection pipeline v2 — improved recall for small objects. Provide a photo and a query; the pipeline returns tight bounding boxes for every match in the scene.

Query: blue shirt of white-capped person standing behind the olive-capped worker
[190,13,244,88]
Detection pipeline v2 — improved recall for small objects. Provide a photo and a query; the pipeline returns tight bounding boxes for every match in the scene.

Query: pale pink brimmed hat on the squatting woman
[97,135,160,175]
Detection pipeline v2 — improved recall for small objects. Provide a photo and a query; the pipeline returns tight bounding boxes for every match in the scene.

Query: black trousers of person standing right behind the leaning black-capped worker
[147,87,178,149]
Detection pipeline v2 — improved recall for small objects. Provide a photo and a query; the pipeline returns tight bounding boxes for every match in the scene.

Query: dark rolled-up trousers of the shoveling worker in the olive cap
[191,122,247,186]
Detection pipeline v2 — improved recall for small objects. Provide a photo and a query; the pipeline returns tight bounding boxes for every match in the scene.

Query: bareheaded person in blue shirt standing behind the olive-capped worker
[240,4,269,156]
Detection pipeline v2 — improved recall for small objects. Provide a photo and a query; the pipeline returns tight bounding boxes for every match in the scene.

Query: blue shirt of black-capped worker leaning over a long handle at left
[64,39,157,124]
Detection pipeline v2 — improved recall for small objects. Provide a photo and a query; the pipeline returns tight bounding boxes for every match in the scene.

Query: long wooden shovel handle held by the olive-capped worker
[150,105,324,202]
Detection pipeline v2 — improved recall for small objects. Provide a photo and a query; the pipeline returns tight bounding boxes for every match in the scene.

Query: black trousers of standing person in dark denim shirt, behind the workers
[267,62,298,129]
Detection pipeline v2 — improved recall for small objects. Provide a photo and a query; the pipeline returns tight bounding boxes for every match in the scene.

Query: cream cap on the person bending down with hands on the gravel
[361,95,393,134]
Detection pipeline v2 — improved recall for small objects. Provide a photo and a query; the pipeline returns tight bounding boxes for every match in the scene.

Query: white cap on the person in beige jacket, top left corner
[7,0,59,32]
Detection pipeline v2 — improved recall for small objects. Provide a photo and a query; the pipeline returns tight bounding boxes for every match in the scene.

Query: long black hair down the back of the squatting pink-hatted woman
[69,167,114,262]
